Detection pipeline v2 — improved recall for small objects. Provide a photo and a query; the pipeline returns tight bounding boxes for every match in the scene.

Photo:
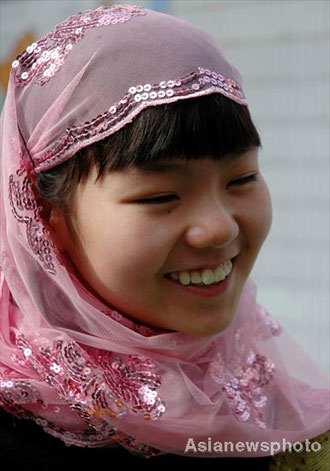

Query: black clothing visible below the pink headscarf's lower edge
[0,407,282,471]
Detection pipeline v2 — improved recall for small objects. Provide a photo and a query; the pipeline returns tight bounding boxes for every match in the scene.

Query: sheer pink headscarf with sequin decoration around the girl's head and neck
[0,6,329,456]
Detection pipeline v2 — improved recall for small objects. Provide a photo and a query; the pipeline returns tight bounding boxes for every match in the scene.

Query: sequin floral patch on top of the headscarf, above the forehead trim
[12,5,146,87]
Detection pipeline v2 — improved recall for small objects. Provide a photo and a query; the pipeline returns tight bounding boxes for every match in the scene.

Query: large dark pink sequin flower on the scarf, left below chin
[18,336,165,427]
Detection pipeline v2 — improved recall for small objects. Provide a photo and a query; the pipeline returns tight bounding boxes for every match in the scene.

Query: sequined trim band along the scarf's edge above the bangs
[33,67,247,172]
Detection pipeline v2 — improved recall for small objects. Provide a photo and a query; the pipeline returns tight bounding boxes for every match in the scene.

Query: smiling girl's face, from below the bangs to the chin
[50,149,272,336]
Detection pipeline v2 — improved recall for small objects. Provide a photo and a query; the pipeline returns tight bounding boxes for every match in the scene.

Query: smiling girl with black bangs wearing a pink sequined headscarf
[0,5,329,469]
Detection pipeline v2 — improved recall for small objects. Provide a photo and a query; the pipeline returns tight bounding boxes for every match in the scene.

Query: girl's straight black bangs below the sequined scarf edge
[76,93,262,179]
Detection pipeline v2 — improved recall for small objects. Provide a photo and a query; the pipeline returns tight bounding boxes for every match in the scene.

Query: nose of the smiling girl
[185,201,239,248]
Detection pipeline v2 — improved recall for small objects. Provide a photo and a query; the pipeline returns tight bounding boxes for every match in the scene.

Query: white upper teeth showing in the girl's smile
[170,260,233,285]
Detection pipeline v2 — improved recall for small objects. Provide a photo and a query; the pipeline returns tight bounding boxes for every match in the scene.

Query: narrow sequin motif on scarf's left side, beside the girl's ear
[9,169,60,275]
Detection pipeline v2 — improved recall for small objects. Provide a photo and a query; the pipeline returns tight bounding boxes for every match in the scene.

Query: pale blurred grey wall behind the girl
[0,0,330,374]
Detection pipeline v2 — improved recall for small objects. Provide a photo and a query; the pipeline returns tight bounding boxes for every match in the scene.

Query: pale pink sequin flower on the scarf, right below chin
[209,329,275,429]
